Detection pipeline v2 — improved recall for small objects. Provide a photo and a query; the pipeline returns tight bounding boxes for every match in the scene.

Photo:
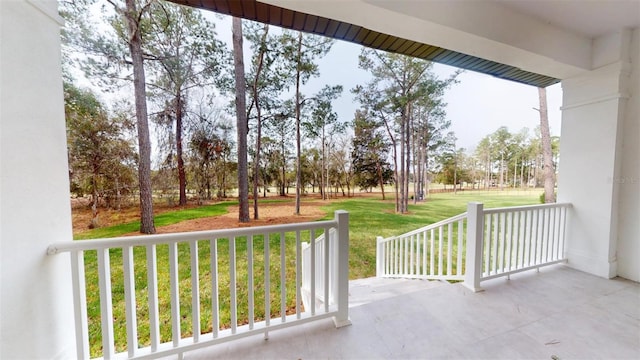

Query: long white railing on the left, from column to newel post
[47,211,350,359]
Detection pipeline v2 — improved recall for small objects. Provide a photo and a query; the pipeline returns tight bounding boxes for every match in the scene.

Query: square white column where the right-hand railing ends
[558,30,637,278]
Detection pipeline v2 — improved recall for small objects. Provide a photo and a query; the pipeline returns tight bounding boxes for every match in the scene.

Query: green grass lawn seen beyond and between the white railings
[81,191,540,356]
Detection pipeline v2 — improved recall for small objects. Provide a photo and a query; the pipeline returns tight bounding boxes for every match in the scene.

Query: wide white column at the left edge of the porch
[0,0,75,359]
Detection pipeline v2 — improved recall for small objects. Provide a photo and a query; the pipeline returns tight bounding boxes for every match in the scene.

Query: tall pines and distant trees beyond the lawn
[61,0,556,233]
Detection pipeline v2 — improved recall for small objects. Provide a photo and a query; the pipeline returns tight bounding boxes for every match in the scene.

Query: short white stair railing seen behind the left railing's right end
[301,228,338,314]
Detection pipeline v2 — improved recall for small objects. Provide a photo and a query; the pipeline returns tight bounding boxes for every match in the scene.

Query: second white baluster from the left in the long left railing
[98,249,115,359]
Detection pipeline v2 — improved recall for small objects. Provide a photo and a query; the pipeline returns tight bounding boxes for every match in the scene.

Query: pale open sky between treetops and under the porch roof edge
[305,41,562,151]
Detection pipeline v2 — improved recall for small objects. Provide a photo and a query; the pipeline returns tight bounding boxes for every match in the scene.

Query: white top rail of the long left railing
[47,220,338,255]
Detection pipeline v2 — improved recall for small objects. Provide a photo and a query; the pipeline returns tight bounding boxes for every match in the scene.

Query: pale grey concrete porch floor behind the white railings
[185,265,640,359]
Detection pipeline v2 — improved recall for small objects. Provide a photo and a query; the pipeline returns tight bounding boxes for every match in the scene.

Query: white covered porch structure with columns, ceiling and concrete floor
[0,0,640,359]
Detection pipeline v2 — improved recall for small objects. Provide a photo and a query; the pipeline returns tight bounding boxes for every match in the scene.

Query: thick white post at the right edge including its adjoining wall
[558,29,640,281]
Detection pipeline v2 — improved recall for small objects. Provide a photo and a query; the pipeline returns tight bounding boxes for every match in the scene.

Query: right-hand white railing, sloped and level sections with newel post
[376,203,571,291]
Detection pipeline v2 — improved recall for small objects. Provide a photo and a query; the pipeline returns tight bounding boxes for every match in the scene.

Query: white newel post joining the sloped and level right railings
[463,202,484,292]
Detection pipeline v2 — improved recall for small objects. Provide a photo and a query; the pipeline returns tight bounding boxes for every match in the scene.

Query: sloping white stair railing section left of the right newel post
[376,213,467,280]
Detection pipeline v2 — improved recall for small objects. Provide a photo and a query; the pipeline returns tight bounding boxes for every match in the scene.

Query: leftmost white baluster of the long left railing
[71,250,89,359]
